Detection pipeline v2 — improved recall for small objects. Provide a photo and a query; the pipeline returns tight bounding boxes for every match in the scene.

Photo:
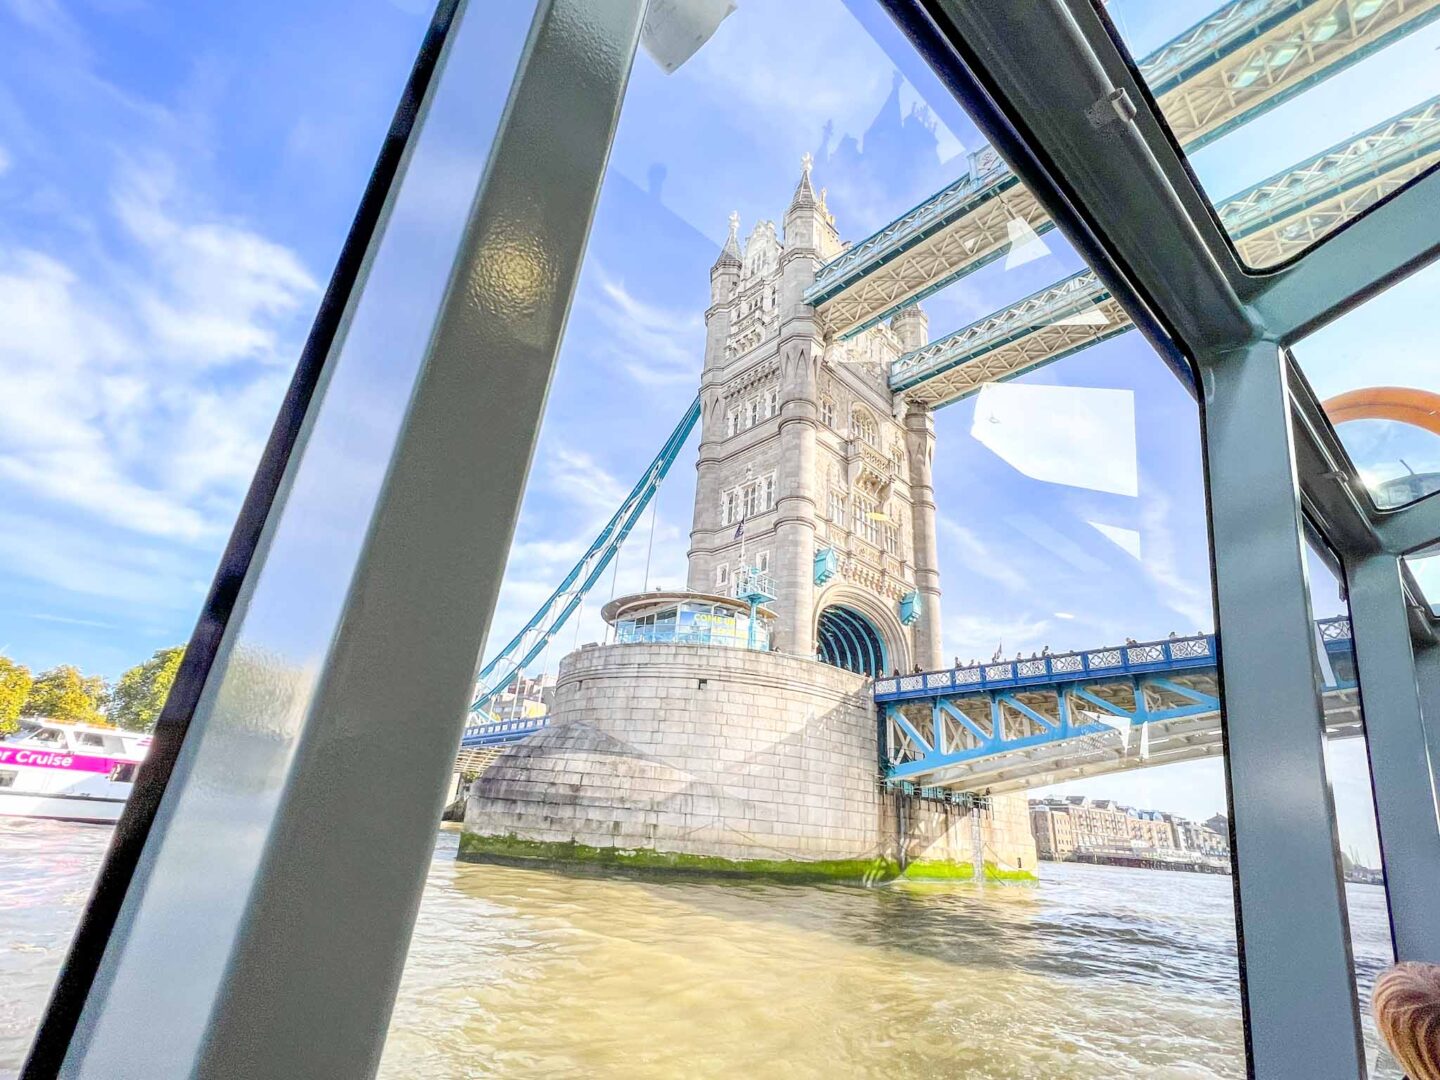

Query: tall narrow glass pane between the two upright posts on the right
[1306,547,1404,1080]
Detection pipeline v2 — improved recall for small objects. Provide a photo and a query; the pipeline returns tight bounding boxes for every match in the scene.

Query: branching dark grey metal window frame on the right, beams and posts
[886,0,1440,1079]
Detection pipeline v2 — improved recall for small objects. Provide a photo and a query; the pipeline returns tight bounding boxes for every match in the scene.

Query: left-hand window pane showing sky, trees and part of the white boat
[0,3,435,1077]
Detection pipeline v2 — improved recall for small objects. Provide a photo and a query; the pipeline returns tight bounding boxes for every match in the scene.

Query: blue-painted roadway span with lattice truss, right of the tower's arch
[874,618,1361,792]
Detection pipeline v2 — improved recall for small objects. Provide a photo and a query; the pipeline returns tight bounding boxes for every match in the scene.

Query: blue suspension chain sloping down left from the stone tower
[461,397,700,747]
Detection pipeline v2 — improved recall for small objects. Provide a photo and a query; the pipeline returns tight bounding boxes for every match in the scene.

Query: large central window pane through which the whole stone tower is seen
[382,1,1246,1079]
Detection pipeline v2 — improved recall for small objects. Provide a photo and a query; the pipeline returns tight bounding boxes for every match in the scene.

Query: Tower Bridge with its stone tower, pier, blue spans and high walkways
[462,0,1440,877]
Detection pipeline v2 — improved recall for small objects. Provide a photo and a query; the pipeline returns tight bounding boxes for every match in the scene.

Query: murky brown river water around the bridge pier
[0,819,1400,1080]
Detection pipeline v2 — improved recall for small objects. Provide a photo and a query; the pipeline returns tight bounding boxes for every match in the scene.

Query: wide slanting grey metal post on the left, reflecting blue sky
[36,0,644,1080]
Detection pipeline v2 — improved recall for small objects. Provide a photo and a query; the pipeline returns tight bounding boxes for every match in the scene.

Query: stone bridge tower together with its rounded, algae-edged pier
[459,158,1035,881]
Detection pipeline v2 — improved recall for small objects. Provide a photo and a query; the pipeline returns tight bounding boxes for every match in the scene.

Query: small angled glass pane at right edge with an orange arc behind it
[1290,256,1440,508]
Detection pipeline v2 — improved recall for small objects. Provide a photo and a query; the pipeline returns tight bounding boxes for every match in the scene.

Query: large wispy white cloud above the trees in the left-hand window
[0,166,318,567]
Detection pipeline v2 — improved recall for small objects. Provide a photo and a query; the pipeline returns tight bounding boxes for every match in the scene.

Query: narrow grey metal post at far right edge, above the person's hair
[1345,554,1440,960]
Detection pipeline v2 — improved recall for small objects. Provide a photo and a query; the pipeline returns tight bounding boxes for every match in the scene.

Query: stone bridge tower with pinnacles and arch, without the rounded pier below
[688,154,943,674]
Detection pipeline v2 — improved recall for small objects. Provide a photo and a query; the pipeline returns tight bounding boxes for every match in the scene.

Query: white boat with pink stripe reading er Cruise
[0,717,150,822]
